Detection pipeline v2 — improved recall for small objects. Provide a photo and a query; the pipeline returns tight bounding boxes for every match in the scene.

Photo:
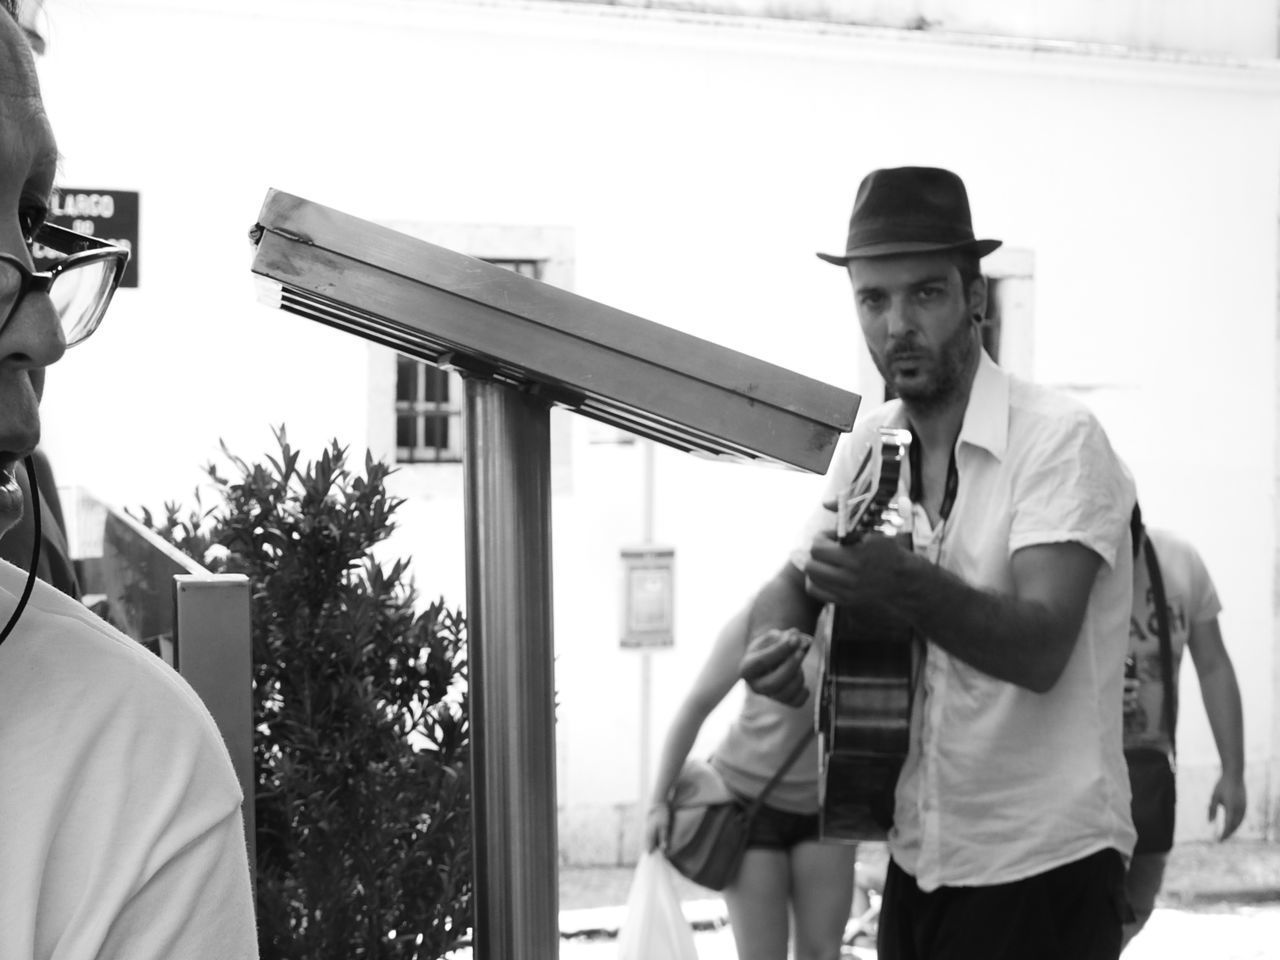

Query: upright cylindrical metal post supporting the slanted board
[463,376,559,960]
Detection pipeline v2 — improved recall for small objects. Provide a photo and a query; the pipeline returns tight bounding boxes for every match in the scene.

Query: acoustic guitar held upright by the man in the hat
[815,428,916,842]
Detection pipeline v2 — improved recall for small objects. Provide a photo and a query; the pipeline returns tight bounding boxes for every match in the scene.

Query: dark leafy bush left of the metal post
[141,428,472,960]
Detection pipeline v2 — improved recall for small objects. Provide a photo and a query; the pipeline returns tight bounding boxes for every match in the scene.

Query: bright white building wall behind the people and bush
[30,0,1280,860]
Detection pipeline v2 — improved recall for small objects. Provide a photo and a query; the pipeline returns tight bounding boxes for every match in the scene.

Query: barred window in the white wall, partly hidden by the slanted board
[396,257,541,463]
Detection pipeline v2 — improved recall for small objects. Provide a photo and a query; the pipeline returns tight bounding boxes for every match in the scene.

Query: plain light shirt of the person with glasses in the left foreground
[0,561,257,960]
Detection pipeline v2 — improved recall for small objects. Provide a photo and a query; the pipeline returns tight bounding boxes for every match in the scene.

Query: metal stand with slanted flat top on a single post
[252,189,859,960]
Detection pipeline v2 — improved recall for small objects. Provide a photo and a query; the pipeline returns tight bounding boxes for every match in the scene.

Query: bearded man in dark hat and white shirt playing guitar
[741,166,1134,960]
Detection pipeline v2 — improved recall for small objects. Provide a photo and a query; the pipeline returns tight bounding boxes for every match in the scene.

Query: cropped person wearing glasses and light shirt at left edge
[0,0,257,960]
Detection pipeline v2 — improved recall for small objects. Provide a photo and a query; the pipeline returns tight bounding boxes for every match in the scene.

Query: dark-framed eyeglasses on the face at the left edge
[0,224,129,347]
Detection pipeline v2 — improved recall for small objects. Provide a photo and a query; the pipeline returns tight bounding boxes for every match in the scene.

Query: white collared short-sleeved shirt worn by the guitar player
[792,355,1134,891]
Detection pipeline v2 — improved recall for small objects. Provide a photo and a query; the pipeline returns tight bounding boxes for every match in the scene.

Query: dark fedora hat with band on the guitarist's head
[818,166,1001,266]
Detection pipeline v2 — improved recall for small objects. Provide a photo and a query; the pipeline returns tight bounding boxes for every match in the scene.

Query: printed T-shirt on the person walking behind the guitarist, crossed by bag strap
[1124,529,1222,751]
